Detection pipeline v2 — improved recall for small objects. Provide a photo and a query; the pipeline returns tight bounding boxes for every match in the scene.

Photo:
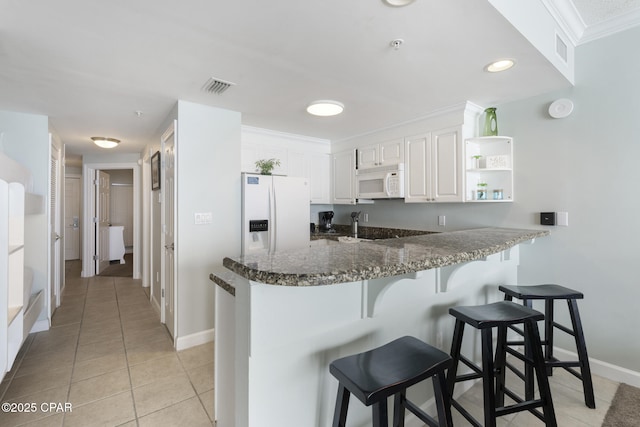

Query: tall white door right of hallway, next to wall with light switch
[161,121,176,337]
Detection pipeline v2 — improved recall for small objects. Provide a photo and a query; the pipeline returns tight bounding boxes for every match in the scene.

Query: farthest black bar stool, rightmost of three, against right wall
[499,284,596,409]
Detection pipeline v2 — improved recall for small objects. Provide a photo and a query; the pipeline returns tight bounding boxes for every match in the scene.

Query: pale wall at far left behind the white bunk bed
[0,111,50,320]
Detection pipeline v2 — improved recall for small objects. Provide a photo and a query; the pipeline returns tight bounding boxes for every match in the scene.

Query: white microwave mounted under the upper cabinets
[356,163,404,199]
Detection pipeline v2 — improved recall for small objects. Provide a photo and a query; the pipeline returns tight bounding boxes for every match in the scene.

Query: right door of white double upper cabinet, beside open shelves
[431,128,463,202]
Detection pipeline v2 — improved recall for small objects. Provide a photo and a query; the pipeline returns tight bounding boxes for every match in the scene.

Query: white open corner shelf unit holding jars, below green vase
[465,136,514,203]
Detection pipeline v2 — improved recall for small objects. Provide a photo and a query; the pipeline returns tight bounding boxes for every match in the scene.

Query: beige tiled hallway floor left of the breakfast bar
[0,261,213,427]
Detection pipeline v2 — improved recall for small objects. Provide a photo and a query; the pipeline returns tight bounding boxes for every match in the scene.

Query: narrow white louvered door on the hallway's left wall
[49,140,63,317]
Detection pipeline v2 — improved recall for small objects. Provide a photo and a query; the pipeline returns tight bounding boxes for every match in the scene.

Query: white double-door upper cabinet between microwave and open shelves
[405,127,464,203]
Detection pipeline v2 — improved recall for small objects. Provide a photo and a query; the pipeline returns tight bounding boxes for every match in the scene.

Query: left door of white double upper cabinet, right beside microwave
[404,134,431,203]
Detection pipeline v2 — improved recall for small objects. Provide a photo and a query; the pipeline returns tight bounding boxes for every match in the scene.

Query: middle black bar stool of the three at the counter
[447,301,557,427]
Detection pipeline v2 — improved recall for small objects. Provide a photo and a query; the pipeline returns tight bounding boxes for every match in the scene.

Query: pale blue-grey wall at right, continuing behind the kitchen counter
[334,28,640,372]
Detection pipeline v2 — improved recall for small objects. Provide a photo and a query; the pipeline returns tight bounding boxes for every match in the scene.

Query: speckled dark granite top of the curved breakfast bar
[223,228,549,286]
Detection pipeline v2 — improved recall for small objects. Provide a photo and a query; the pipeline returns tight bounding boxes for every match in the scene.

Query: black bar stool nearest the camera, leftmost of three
[329,336,453,427]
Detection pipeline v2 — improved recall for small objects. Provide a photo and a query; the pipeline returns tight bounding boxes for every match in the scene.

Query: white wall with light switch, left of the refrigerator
[176,101,240,348]
